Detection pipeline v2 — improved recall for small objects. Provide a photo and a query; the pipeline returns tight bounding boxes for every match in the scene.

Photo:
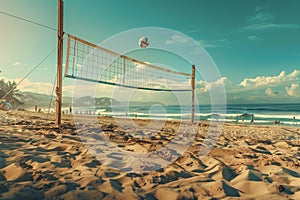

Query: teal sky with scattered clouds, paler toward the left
[0,0,300,103]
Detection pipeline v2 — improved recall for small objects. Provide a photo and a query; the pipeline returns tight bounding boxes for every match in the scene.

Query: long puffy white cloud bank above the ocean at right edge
[239,70,300,88]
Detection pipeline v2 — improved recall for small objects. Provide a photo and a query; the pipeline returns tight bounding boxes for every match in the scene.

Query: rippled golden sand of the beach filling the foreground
[0,111,300,200]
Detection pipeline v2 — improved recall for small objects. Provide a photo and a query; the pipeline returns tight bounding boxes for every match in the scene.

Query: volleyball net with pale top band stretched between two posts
[65,35,194,91]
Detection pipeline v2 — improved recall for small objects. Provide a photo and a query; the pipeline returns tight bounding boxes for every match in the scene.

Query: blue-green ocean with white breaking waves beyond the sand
[77,104,300,126]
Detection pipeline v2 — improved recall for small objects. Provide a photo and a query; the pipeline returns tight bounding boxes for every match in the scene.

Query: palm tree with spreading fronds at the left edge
[0,79,23,106]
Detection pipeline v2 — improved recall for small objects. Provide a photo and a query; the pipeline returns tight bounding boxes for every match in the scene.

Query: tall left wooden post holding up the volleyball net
[56,0,64,125]
